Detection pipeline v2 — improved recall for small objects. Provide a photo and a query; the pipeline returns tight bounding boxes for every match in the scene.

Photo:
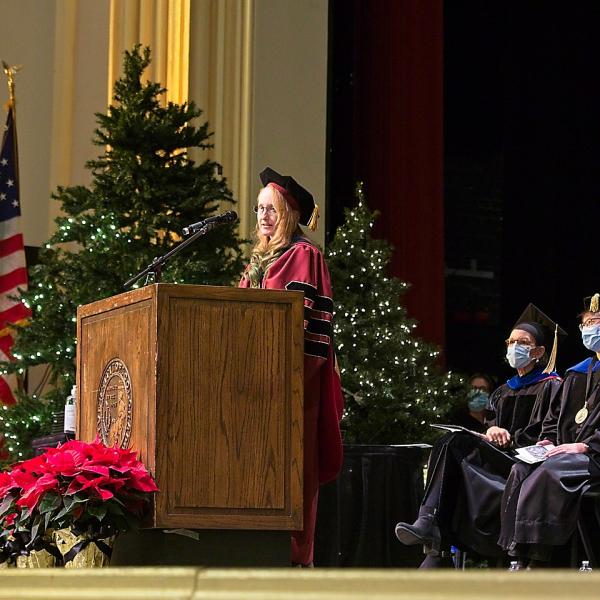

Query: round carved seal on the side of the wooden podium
[97,358,133,448]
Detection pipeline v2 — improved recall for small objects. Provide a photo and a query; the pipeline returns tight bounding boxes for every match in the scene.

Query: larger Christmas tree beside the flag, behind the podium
[0,46,242,459]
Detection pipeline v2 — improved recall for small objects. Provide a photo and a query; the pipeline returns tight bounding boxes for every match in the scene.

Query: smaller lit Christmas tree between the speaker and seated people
[327,184,466,444]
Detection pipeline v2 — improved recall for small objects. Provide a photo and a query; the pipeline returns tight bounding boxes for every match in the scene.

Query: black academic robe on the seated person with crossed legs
[422,371,561,556]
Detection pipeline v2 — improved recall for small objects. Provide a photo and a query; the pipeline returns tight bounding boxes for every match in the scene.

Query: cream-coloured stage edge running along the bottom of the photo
[0,568,600,600]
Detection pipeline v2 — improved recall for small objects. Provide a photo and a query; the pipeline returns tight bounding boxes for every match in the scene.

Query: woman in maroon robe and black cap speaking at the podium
[240,167,343,566]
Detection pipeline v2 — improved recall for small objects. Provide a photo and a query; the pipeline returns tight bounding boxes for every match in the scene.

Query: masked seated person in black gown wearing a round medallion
[499,294,600,565]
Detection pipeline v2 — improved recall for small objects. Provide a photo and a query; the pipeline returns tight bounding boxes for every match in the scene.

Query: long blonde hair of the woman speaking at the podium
[246,185,302,287]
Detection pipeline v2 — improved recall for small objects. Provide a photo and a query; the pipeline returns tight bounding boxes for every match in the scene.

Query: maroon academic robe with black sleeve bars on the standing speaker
[240,238,343,564]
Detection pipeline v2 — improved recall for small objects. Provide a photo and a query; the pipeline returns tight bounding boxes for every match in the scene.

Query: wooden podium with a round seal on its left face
[77,284,304,539]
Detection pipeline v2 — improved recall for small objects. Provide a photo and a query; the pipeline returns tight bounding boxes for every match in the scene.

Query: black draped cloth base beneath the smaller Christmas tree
[315,446,429,567]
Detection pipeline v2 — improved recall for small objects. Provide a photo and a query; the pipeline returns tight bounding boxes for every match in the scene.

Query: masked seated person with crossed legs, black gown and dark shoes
[396,304,566,567]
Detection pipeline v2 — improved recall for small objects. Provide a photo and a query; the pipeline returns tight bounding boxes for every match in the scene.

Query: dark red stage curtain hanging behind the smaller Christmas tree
[353,0,444,345]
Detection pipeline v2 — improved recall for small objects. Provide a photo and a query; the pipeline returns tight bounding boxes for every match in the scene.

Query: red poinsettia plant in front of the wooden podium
[0,440,158,558]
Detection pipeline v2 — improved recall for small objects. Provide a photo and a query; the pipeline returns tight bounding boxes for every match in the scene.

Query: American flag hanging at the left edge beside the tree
[0,107,31,404]
